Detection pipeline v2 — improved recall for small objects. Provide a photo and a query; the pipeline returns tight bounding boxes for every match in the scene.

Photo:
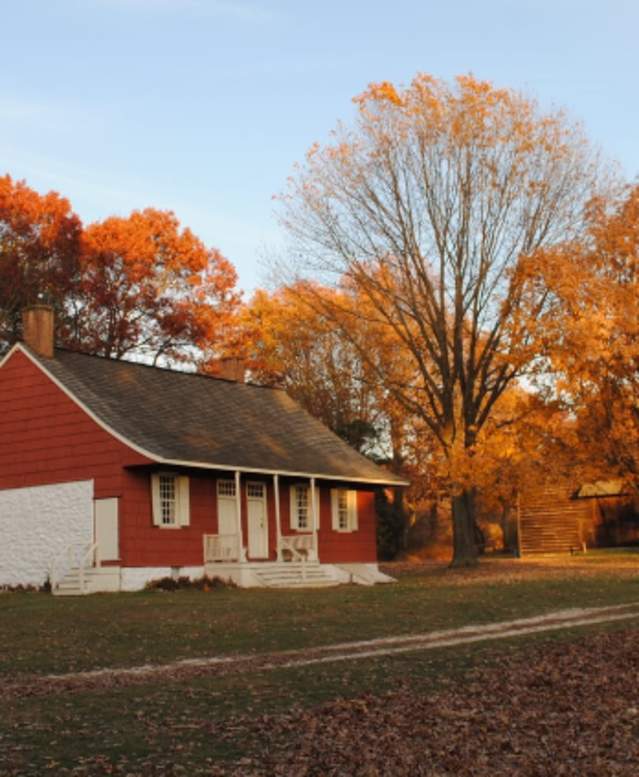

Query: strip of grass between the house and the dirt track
[0,556,639,677]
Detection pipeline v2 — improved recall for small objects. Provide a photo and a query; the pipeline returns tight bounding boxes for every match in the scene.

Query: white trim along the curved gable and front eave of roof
[0,343,410,486]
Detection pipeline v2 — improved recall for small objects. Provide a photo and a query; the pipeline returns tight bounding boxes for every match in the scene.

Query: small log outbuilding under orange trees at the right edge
[517,480,639,556]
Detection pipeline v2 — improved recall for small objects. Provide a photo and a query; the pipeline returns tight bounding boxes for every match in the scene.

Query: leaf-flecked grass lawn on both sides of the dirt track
[0,555,639,777]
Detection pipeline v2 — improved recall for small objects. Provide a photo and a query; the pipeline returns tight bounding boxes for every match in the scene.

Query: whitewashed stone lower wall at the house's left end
[0,480,93,586]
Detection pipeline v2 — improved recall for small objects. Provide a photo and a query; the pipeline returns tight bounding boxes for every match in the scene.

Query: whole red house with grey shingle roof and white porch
[0,306,402,593]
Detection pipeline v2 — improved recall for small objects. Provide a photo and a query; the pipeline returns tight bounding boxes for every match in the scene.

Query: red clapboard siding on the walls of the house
[0,351,376,567]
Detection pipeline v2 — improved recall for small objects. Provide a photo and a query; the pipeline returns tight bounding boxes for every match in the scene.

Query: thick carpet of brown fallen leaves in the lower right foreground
[0,629,639,777]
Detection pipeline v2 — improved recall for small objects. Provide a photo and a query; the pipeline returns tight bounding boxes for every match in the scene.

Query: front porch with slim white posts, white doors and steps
[202,470,391,588]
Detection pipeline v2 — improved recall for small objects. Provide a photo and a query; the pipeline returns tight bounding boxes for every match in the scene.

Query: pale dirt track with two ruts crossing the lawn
[0,602,639,698]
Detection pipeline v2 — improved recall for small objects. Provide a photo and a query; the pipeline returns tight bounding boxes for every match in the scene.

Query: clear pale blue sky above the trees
[0,0,639,289]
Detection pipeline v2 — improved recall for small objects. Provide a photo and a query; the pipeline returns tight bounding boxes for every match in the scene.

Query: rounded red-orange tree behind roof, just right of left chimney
[63,208,239,364]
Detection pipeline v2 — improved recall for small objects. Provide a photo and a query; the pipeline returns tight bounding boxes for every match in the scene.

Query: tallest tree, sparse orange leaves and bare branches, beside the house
[282,75,599,564]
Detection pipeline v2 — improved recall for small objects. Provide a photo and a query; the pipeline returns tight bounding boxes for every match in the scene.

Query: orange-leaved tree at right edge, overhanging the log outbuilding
[520,186,639,488]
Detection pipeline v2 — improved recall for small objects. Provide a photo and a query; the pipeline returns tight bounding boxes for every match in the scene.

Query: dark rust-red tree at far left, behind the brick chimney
[0,175,82,353]
